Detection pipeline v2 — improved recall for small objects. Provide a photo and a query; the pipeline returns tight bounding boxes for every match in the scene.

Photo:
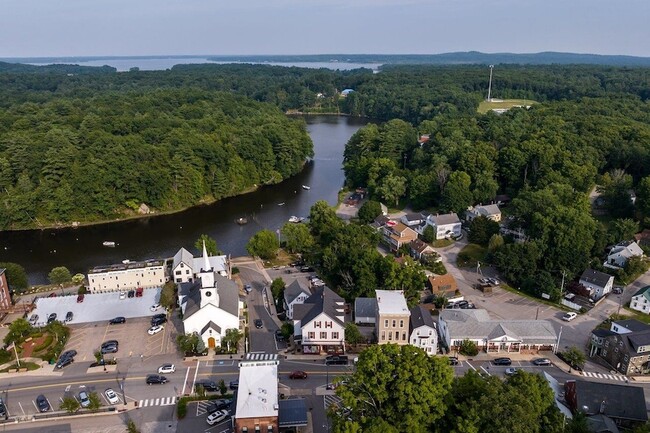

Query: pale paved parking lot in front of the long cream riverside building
[30,288,161,326]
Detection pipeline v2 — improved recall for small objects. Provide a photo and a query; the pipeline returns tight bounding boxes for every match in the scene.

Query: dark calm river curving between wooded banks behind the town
[0,116,366,284]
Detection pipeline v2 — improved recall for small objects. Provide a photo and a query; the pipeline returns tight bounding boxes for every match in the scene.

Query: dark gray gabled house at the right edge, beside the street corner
[591,319,650,376]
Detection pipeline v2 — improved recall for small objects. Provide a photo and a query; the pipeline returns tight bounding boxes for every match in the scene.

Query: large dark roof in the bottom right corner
[576,380,648,422]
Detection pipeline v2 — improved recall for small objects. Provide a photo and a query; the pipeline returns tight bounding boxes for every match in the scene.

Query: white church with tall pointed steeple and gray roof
[178,244,243,348]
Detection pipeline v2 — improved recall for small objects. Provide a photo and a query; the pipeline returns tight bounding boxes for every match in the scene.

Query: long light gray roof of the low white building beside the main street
[439,309,557,344]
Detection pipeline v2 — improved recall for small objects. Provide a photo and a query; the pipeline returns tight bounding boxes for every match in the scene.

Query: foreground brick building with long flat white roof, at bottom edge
[231,353,280,433]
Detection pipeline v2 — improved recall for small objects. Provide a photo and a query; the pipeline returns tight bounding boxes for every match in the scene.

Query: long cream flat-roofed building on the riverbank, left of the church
[87,259,167,292]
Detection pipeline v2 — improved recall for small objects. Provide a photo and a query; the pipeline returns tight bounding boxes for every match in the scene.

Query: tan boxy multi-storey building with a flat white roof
[375,290,411,345]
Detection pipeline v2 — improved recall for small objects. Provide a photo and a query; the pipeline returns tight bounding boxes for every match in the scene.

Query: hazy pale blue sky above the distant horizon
[0,0,650,57]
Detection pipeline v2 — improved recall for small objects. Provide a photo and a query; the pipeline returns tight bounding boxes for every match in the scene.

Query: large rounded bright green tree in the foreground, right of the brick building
[333,344,453,433]
